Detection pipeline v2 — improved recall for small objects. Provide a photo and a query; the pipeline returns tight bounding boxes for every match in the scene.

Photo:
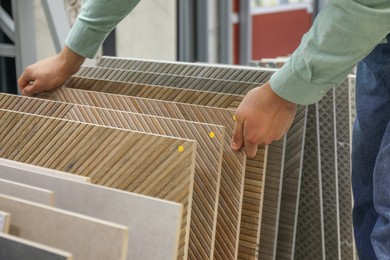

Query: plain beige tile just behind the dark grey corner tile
[0,195,129,260]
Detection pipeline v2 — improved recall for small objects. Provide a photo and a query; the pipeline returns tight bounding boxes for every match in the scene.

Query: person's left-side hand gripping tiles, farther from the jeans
[18,47,85,96]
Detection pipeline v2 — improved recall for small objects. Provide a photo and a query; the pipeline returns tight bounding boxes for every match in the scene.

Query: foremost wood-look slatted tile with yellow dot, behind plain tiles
[0,110,196,258]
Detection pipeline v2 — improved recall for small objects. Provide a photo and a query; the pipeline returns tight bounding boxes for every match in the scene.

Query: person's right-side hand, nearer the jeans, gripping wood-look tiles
[231,82,297,158]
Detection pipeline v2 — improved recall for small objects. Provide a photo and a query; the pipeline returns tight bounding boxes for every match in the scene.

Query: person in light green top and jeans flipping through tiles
[18,0,390,260]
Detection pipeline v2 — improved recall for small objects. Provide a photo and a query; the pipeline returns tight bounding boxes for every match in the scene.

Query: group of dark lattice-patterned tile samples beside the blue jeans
[252,60,356,259]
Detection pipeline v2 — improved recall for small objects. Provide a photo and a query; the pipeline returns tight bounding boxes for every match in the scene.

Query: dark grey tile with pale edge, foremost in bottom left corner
[0,234,73,260]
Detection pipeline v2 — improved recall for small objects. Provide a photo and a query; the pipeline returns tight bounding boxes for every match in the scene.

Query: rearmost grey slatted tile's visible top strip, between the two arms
[97,56,275,83]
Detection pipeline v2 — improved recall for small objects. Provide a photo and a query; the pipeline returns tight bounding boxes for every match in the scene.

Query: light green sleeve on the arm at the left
[65,0,140,58]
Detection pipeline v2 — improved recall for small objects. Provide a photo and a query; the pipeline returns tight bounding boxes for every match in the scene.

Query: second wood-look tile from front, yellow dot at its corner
[0,95,225,259]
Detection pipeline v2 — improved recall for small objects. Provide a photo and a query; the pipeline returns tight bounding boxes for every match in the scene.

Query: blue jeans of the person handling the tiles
[352,37,390,260]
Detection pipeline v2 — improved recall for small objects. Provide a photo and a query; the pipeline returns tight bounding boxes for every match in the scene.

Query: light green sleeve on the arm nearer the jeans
[270,0,390,104]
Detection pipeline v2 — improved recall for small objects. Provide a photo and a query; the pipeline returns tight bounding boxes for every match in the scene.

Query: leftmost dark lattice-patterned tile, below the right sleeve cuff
[294,104,325,259]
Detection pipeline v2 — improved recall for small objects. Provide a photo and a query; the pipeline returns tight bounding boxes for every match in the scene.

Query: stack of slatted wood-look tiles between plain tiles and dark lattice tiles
[0,57,307,259]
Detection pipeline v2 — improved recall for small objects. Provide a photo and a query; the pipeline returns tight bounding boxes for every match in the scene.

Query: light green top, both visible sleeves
[66,0,390,104]
